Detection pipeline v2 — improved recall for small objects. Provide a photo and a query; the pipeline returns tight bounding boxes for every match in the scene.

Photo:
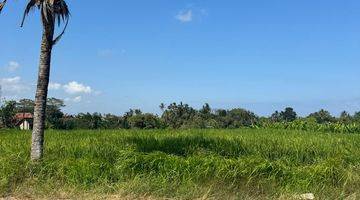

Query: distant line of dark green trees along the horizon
[0,98,360,132]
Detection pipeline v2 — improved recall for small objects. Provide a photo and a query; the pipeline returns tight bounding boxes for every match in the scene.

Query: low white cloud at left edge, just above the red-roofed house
[0,76,29,94]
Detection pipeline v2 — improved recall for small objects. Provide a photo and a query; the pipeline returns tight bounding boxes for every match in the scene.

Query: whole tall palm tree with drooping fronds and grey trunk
[0,0,70,161]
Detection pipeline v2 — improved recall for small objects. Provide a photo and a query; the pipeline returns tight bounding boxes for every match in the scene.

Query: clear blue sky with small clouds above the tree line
[0,0,360,115]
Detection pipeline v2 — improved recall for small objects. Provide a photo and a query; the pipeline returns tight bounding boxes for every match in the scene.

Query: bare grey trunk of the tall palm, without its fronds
[31,16,54,161]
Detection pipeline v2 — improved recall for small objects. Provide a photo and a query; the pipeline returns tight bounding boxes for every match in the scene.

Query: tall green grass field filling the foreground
[0,129,360,199]
